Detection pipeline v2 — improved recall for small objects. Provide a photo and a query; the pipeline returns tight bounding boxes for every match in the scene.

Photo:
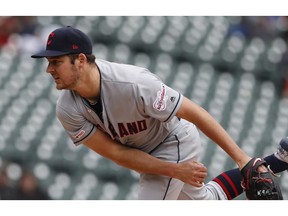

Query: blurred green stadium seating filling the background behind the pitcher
[0,16,288,200]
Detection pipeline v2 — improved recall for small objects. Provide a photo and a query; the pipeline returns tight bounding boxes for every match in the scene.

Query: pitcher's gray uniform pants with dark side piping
[138,120,227,200]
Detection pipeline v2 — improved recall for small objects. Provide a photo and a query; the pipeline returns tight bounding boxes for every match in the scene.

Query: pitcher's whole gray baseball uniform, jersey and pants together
[56,59,225,200]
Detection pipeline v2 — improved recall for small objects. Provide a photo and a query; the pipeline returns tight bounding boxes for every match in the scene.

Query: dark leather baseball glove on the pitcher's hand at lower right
[241,157,283,200]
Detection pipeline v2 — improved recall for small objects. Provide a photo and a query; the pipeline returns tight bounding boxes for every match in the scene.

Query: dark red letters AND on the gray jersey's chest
[118,120,147,137]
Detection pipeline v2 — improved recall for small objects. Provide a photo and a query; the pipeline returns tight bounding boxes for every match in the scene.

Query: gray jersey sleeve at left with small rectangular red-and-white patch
[56,105,96,145]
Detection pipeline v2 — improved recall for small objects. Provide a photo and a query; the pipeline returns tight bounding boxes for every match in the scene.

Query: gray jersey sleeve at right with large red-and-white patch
[137,72,183,122]
